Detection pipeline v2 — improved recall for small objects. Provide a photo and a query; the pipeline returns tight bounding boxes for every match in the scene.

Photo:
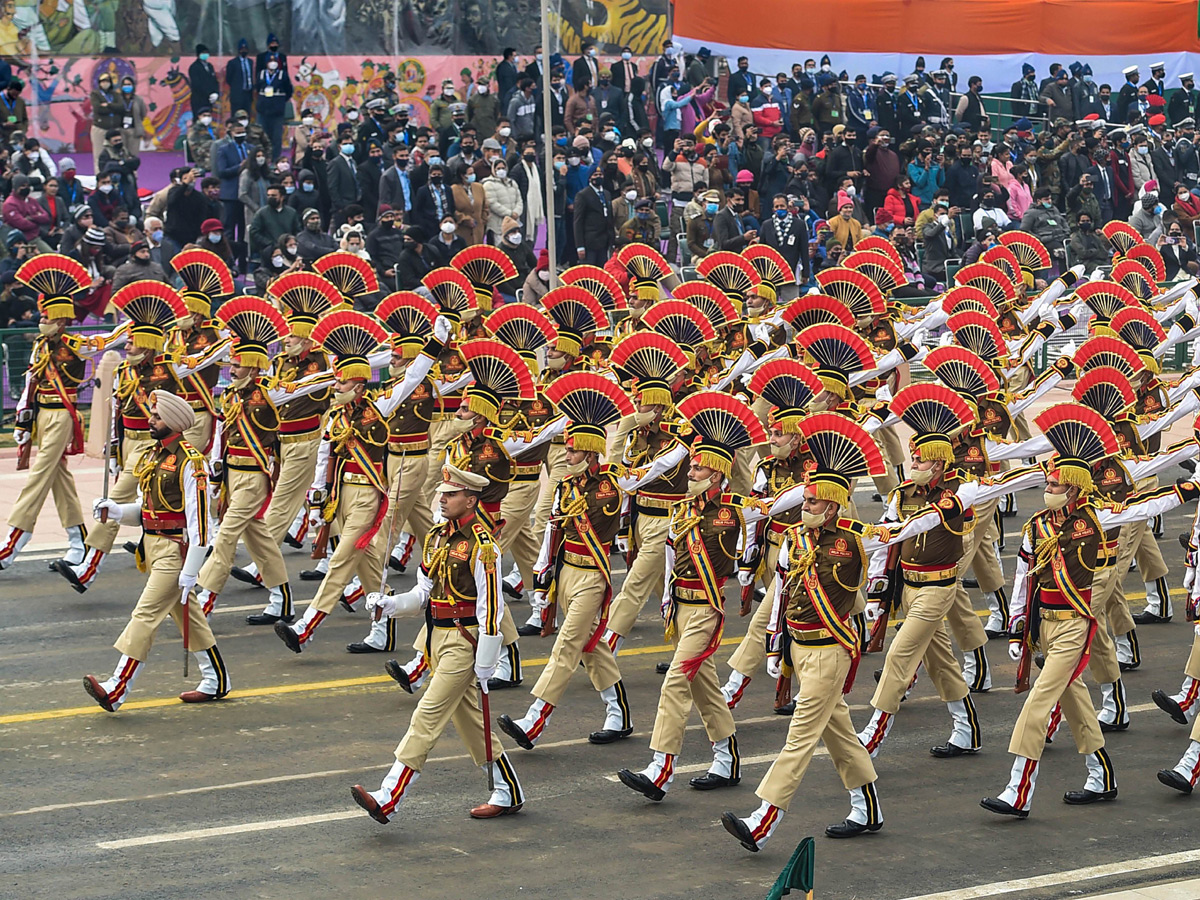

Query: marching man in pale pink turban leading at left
[83,390,229,713]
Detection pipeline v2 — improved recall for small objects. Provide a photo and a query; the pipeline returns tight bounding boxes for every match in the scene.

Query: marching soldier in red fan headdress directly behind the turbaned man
[50,281,228,594]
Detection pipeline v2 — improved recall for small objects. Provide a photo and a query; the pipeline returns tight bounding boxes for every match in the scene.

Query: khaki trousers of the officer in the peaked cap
[396,625,504,772]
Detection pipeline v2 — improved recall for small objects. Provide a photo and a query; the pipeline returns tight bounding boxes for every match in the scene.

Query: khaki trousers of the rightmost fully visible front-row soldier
[1008,618,1104,760]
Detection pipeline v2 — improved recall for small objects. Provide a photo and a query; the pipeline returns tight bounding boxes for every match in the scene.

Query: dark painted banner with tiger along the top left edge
[0,0,670,59]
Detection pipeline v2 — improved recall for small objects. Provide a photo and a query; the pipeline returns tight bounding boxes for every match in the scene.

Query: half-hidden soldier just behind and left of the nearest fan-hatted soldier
[721,359,830,709]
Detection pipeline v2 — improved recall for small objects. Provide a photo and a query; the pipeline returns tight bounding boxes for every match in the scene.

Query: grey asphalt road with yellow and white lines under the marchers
[7,487,1200,900]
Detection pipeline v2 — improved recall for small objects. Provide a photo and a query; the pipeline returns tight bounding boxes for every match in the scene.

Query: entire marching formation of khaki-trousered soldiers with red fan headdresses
[11,229,1200,868]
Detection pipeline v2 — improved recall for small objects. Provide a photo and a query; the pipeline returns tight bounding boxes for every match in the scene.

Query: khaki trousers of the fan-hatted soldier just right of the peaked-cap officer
[530,565,620,707]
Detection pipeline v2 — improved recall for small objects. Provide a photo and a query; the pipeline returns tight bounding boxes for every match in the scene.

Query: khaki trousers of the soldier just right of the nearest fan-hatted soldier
[871,584,970,715]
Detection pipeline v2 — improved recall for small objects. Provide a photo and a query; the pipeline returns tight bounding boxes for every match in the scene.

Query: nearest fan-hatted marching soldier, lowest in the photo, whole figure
[721,413,979,852]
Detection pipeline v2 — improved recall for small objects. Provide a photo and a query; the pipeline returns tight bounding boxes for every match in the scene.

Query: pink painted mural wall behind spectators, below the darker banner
[19,55,653,152]
